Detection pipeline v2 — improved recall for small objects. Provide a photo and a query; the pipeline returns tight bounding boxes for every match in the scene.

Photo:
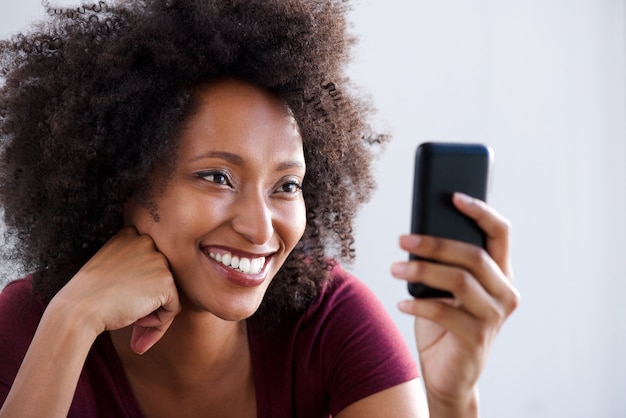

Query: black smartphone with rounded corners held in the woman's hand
[408,142,493,298]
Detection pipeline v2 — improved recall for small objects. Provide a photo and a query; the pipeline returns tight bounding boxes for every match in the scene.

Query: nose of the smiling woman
[231,190,274,245]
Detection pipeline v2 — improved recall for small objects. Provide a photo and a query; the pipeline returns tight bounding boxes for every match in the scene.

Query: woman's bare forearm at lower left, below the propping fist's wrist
[0,298,97,418]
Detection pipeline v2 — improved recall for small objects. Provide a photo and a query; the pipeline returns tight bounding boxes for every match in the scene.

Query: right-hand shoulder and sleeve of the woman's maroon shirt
[246,267,418,417]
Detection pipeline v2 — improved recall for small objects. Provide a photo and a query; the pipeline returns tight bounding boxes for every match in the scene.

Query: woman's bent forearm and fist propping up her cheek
[0,228,180,417]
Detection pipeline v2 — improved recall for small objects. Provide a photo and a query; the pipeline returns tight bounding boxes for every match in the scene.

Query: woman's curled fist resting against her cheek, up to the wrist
[51,228,180,353]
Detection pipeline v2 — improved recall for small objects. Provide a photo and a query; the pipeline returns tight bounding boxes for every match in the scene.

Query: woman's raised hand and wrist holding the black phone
[392,194,519,417]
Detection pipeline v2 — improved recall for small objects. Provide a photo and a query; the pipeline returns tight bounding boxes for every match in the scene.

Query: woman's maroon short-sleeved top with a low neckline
[0,268,418,418]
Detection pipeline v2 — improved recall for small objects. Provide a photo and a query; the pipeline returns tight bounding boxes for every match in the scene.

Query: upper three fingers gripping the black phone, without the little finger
[392,193,519,318]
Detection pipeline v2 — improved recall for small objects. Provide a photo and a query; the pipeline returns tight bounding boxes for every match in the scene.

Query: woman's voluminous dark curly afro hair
[0,0,387,316]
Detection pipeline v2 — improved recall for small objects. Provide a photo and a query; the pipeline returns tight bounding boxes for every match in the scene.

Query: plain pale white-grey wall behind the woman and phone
[0,0,626,418]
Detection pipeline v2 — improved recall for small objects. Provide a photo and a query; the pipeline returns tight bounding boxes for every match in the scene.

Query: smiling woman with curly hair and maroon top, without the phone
[0,0,518,418]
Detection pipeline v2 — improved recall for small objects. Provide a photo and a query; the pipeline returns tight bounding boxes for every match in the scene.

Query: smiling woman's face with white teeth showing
[125,80,306,320]
